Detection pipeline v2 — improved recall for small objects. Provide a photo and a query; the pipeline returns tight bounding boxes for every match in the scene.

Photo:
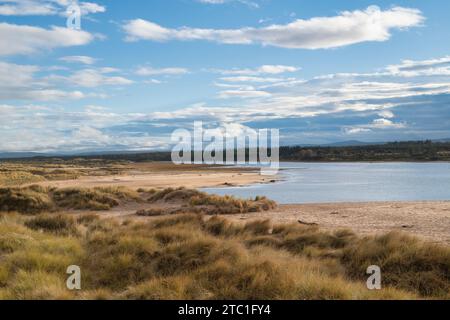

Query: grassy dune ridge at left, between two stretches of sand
[0,185,276,216]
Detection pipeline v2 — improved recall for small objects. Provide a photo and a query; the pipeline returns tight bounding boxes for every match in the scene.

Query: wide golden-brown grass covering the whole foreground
[0,214,450,299]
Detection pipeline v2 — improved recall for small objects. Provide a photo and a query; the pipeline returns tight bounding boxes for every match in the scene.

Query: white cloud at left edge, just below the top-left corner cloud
[0,23,94,56]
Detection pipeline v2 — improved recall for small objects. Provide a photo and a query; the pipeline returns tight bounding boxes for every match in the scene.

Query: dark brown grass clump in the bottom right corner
[342,232,450,297]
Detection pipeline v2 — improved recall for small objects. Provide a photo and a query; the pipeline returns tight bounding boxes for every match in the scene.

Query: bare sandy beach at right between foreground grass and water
[227,201,450,244]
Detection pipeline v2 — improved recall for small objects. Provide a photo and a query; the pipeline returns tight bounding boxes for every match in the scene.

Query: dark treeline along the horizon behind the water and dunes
[5,141,450,162]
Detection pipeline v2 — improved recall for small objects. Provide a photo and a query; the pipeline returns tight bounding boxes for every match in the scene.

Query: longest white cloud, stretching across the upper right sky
[123,6,424,49]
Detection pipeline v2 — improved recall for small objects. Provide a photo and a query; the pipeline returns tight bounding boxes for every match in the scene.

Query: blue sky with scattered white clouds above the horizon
[0,0,450,151]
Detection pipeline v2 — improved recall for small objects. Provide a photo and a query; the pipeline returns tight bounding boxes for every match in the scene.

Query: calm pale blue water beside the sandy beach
[204,162,450,204]
